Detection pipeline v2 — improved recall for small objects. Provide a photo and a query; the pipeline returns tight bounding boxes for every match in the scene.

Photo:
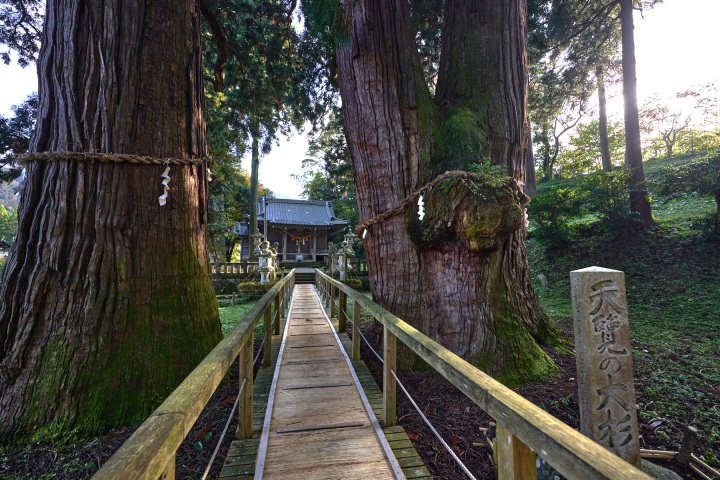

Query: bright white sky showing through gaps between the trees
[0,0,720,198]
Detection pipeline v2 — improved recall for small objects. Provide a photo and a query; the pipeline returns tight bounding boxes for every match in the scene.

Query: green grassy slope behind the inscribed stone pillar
[529,156,720,464]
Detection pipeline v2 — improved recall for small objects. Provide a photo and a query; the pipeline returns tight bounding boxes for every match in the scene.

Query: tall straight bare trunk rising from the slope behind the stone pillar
[620,0,655,227]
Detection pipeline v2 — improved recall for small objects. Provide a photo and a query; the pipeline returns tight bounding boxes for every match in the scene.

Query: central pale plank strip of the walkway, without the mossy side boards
[255,285,402,479]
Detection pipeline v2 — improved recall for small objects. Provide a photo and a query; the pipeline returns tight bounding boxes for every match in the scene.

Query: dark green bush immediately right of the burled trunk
[528,186,584,247]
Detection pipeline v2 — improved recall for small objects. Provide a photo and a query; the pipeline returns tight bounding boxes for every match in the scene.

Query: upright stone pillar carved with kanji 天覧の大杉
[570,267,640,466]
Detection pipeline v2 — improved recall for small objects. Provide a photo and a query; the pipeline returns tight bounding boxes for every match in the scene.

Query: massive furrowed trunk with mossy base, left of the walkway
[0,0,221,440]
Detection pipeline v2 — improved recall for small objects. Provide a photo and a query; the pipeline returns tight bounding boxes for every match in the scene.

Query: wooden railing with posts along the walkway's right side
[315,270,650,480]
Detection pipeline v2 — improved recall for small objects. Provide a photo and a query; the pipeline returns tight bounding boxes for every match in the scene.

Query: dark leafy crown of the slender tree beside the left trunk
[203,0,308,156]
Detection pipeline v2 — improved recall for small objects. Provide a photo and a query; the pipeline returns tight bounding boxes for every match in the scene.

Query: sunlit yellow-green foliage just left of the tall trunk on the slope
[556,120,625,178]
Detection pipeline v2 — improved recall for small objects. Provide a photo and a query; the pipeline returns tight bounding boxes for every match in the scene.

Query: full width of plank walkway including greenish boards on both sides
[219,285,430,480]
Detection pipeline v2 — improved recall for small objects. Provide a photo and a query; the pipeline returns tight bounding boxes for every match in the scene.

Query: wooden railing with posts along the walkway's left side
[93,270,295,480]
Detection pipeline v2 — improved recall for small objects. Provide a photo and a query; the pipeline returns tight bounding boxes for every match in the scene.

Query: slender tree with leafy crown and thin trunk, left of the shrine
[201,0,308,248]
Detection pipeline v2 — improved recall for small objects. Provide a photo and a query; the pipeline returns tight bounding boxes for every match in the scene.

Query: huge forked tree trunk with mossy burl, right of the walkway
[338,0,556,382]
